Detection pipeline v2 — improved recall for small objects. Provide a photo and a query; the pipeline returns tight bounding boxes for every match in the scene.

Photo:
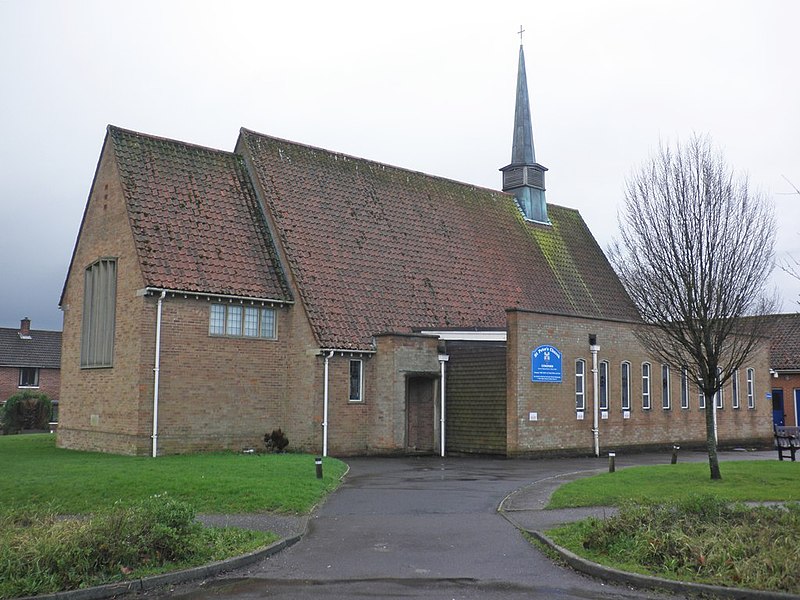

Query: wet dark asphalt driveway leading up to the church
[158,453,768,600]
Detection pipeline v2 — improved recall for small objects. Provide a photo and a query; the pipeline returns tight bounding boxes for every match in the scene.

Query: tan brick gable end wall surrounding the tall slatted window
[58,145,152,454]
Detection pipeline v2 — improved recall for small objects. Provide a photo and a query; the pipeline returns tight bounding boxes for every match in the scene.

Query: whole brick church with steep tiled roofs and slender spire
[58,46,771,456]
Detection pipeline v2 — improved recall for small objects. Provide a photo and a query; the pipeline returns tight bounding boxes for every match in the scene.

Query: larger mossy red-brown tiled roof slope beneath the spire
[237,129,638,349]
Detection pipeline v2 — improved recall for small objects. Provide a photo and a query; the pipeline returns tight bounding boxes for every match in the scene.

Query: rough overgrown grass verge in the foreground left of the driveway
[0,495,278,599]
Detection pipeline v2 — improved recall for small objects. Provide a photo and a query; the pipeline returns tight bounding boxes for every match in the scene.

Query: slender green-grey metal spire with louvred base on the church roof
[500,37,550,223]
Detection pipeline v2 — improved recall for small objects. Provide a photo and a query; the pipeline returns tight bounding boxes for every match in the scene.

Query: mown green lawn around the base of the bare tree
[548,460,800,508]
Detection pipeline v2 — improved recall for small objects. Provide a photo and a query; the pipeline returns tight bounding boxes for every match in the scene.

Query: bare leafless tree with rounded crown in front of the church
[611,135,777,479]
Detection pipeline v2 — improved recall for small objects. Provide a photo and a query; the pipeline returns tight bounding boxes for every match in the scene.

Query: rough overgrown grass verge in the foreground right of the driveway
[547,496,800,594]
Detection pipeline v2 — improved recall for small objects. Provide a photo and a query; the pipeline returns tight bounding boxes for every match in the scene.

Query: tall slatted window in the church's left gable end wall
[81,258,117,367]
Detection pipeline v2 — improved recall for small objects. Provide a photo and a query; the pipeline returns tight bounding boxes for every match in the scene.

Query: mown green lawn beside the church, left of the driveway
[0,434,347,514]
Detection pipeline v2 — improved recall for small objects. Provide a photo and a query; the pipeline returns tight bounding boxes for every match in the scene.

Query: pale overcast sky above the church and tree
[0,0,800,329]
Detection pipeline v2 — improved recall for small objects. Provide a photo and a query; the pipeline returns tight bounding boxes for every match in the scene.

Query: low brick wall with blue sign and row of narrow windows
[508,311,772,454]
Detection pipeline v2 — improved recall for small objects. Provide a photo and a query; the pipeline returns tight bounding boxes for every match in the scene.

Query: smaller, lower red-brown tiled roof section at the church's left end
[108,126,291,300]
